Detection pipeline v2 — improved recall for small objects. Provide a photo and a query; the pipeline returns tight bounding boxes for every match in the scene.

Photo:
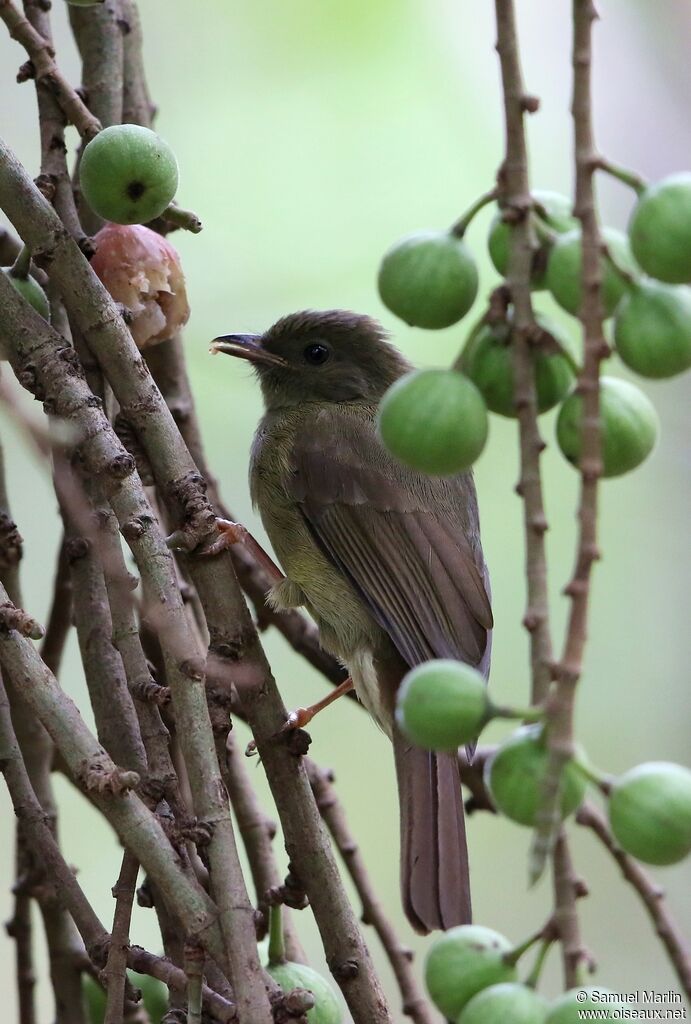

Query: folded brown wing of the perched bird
[288,407,492,666]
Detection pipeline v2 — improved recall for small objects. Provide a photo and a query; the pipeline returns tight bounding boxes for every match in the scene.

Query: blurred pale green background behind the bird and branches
[0,0,691,1022]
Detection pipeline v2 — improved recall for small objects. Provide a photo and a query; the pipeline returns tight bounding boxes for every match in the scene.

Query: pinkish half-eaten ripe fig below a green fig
[91,224,189,349]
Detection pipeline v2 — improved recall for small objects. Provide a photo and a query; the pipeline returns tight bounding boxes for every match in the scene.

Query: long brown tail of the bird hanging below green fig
[393,728,471,934]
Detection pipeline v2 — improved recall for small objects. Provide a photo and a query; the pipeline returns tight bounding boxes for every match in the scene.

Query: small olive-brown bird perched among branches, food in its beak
[213,310,492,933]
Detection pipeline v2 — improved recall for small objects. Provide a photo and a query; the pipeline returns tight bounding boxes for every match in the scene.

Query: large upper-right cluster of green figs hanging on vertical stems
[379,173,691,476]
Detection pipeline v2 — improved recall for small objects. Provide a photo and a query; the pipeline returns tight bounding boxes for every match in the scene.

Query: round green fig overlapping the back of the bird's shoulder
[379,370,488,476]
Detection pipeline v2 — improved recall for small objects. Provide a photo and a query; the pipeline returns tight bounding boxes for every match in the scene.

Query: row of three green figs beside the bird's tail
[396,660,691,864]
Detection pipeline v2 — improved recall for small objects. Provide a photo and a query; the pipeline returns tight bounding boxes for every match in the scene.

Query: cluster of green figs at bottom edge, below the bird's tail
[425,925,622,1024]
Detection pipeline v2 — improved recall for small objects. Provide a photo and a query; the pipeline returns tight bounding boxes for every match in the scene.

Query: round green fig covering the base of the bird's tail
[396,660,491,751]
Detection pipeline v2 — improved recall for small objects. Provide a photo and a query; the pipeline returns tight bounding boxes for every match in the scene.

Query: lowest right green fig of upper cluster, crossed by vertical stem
[557,377,659,476]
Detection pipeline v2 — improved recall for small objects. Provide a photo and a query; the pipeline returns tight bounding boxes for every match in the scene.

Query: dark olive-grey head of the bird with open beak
[211,309,411,410]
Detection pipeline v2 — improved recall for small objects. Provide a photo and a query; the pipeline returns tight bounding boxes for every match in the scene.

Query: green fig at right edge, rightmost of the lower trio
[609,761,691,864]
